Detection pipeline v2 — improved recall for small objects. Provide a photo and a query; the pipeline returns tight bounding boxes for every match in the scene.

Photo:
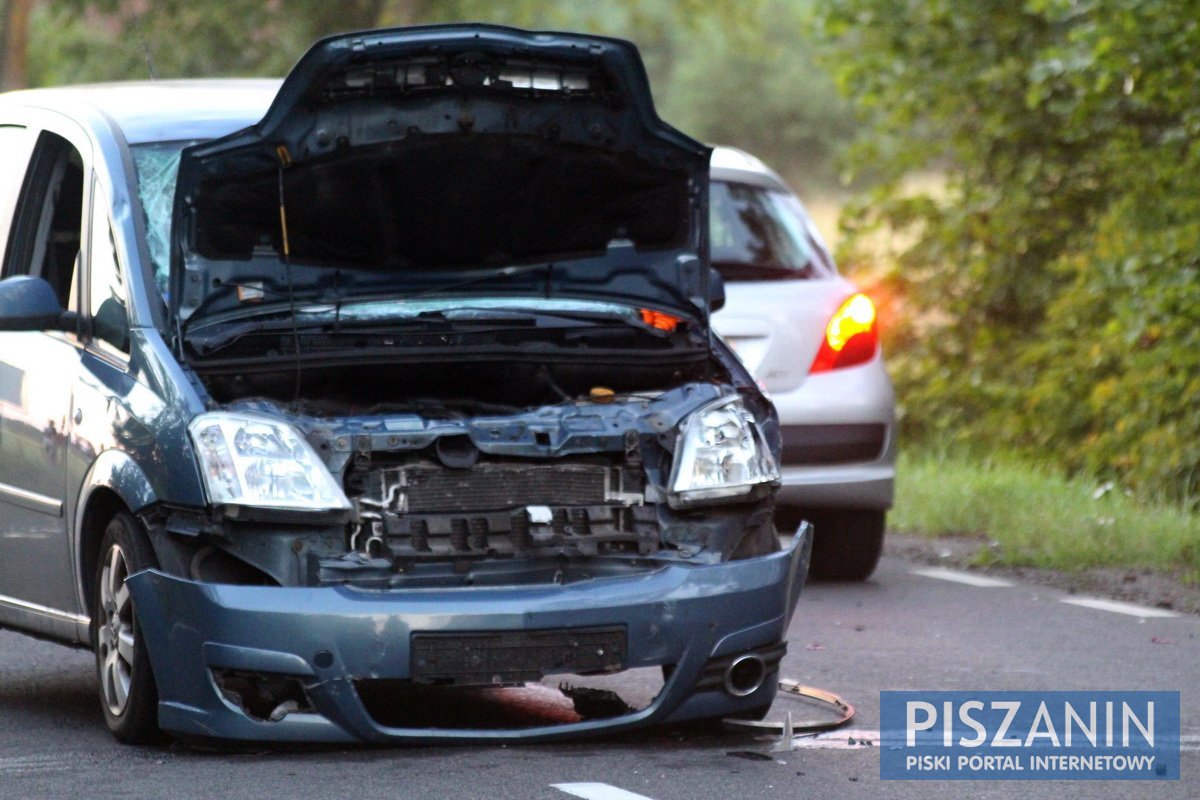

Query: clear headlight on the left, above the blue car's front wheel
[187,411,350,511]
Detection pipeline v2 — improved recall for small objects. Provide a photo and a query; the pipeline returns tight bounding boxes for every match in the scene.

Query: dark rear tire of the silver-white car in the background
[776,509,887,581]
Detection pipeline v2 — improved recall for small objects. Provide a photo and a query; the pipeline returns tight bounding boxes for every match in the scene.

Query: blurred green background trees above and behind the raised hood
[11,0,853,187]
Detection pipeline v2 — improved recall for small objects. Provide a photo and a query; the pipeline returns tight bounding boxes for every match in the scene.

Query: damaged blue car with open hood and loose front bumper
[0,25,811,742]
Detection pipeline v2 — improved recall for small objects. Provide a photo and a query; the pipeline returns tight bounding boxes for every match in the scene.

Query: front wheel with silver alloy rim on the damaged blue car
[91,512,162,745]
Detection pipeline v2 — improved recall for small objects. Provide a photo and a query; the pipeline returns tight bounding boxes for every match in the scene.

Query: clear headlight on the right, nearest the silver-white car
[671,397,779,505]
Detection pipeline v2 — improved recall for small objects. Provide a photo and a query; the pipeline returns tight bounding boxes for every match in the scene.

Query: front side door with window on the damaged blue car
[0,120,90,632]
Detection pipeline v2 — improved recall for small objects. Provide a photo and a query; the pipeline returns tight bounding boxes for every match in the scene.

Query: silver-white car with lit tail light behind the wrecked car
[709,148,895,581]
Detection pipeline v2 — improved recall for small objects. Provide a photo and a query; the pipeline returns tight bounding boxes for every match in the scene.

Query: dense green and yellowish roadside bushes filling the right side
[818,0,1200,506]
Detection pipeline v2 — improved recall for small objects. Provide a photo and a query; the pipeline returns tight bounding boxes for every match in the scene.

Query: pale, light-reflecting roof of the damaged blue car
[0,78,282,144]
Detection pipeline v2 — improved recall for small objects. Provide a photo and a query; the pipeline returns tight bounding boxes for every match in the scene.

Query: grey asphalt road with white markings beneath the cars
[0,558,1200,800]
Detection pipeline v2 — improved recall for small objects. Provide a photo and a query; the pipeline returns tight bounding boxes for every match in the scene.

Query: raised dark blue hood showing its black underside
[169,25,710,320]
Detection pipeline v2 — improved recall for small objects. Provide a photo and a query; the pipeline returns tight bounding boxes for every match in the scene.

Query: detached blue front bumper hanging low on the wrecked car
[127,525,811,742]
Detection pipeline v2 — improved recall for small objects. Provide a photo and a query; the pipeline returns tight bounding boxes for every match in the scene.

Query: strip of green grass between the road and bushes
[889,452,1200,584]
